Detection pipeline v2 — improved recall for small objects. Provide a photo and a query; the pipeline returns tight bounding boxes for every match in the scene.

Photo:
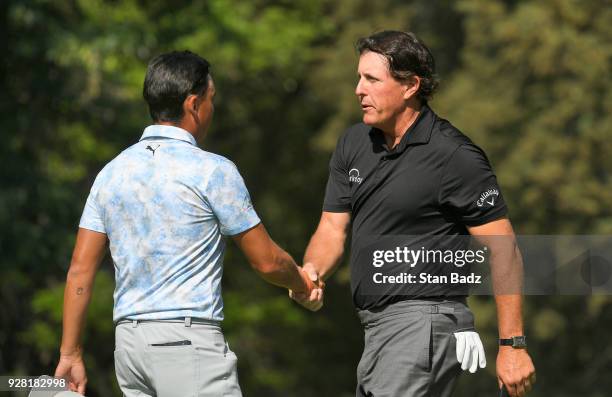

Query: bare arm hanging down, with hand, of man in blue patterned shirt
[55,228,107,394]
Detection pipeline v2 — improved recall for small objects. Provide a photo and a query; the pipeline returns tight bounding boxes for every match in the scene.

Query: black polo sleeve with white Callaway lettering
[439,144,508,226]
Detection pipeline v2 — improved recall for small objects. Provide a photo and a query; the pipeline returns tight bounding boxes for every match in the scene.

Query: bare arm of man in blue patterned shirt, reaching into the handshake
[232,223,315,293]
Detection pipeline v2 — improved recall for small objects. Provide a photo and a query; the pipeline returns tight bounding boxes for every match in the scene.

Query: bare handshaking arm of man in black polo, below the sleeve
[304,212,351,279]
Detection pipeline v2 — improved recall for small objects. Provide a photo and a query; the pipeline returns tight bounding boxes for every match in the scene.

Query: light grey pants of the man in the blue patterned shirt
[115,318,242,397]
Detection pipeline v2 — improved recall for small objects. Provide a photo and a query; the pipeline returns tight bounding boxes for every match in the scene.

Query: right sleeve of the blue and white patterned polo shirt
[205,161,261,236]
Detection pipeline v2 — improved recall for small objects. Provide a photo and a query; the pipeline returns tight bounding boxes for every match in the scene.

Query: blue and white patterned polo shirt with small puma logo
[79,125,260,321]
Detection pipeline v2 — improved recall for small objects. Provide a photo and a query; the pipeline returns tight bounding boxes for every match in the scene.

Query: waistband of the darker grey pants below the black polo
[357,297,467,325]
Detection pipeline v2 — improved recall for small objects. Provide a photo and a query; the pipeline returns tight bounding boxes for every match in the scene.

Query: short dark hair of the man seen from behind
[142,51,210,122]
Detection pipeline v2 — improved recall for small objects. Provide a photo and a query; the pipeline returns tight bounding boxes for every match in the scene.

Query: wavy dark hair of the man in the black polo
[357,30,438,102]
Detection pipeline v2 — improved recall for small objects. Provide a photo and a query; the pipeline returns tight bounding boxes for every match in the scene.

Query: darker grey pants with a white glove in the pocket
[356,300,474,397]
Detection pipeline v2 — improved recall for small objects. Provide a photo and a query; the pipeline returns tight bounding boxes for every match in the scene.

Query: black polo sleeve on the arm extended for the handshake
[323,135,351,212]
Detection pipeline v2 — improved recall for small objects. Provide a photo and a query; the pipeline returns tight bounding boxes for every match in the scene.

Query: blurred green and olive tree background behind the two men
[0,0,612,397]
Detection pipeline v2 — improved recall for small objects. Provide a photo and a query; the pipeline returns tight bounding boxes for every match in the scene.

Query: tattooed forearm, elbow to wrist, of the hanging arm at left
[60,270,95,355]
